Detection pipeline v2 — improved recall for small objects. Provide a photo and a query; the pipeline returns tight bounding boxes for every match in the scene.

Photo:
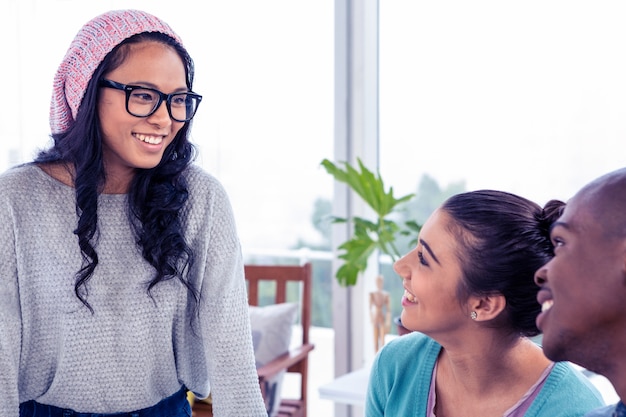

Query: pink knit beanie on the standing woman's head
[50,10,182,133]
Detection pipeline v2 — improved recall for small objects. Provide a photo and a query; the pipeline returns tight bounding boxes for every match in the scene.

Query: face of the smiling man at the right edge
[535,192,626,372]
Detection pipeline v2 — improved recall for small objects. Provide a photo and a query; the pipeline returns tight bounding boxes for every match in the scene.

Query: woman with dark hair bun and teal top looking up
[365,190,603,417]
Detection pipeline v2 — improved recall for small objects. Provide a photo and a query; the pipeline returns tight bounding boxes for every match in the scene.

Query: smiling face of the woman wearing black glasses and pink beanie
[98,41,188,184]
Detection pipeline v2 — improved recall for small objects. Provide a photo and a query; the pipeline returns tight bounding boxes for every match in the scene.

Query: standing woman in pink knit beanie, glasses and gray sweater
[0,10,267,417]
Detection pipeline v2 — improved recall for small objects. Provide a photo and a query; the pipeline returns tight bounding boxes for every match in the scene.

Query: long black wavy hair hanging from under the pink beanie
[35,32,198,313]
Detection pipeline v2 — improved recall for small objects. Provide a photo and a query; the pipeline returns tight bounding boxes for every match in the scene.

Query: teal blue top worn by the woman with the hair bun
[365,332,604,417]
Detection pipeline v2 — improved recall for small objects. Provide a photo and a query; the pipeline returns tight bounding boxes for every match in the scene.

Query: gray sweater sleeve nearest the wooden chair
[189,171,267,417]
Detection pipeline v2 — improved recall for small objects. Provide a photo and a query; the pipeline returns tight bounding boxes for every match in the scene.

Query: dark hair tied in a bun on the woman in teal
[441,190,565,337]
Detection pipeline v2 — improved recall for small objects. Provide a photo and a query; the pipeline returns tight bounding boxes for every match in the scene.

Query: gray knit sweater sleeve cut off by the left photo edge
[0,194,22,417]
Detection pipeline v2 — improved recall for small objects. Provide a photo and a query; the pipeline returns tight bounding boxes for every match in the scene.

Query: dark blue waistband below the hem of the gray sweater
[20,387,191,417]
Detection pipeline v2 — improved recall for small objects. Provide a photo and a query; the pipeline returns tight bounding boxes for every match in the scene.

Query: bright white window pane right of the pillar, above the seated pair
[380,0,626,204]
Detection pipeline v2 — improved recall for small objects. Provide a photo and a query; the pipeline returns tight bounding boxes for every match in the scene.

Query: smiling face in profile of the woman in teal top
[394,210,469,338]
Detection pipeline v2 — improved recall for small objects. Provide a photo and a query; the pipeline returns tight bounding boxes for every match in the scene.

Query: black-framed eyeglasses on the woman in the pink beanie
[99,78,202,122]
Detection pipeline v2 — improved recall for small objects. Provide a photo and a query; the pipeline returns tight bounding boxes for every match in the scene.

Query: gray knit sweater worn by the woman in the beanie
[0,164,266,417]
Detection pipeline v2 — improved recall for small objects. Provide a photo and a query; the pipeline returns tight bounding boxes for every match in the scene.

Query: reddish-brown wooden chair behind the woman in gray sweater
[192,263,315,417]
